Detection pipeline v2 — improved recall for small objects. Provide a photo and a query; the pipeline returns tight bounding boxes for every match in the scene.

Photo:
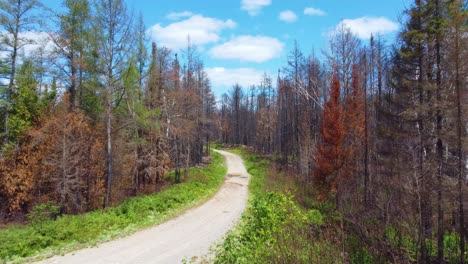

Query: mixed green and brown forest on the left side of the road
[0,0,219,218]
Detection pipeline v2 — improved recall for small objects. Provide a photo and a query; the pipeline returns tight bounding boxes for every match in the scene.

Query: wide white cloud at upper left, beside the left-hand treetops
[148,15,236,49]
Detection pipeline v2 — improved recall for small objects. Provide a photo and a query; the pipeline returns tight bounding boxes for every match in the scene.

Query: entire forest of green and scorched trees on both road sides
[0,0,468,263]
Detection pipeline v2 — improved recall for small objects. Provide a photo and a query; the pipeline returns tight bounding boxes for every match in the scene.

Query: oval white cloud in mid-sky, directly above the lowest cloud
[210,35,284,63]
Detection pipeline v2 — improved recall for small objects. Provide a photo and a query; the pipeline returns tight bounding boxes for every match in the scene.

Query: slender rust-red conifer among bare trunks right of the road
[314,74,346,199]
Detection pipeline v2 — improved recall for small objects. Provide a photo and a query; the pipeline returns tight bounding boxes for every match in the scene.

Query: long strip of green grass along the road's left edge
[0,150,226,263]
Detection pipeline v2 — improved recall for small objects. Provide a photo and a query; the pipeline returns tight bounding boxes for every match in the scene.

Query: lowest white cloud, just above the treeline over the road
[205,67,263,88]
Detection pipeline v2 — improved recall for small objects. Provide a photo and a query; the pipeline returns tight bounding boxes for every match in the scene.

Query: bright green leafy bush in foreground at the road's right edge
[215,192,307,263]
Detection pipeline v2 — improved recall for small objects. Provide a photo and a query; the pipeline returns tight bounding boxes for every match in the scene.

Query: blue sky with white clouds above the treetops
[43,0,411,95]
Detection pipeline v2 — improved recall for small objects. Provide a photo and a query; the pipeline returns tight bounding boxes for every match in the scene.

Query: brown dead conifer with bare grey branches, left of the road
[29,101,105,213]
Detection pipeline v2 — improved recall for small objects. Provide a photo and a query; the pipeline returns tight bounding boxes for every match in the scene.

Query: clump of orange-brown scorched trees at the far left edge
[0,95,105,215]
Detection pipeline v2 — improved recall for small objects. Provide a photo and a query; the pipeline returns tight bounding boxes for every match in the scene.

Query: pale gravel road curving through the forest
[39,151,249,264]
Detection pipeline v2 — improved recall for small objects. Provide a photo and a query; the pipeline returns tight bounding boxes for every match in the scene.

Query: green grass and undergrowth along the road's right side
[215,148,341,263]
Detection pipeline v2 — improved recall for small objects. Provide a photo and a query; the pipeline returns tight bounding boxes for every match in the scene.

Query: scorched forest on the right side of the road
[219,0,468,263]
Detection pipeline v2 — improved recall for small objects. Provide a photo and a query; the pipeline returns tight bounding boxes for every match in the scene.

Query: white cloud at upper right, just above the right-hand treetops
[335,16,398,39]
